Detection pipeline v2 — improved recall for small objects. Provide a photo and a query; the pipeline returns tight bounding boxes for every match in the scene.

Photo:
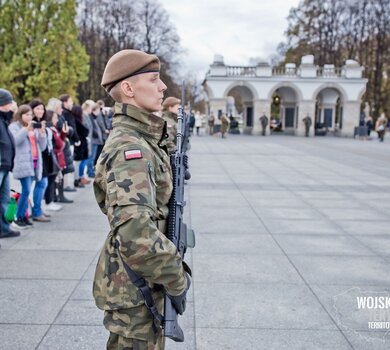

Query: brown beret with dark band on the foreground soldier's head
[101,50,160,92]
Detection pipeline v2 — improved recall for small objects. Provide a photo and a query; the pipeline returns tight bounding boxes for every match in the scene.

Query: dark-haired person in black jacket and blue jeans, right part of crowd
[72,105,90,187]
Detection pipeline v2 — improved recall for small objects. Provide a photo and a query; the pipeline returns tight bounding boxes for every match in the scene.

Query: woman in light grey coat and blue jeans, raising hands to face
[9,105,47,229]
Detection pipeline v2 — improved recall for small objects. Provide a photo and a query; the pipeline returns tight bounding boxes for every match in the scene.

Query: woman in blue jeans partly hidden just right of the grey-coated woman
[30,99,51,222]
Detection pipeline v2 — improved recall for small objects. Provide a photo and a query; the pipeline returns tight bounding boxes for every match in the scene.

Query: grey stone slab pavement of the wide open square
[0,135,390,350]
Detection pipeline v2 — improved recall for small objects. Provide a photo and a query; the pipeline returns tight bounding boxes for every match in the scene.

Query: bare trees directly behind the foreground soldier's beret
[78,0,181,100]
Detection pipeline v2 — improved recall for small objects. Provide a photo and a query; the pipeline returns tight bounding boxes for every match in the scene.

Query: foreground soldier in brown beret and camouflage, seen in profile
[93,50,190,350]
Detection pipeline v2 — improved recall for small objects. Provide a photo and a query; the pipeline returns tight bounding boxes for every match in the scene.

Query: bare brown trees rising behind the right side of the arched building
[279,0,390,117]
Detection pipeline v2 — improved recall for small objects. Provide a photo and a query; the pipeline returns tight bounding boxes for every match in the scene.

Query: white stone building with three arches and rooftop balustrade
[203,55,367,137]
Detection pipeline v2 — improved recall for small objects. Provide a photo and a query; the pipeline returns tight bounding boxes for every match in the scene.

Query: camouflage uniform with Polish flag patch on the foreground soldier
[93,103,186,350]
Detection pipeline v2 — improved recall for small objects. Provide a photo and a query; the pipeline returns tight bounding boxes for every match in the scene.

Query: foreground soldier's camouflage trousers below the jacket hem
[107,332,165,350]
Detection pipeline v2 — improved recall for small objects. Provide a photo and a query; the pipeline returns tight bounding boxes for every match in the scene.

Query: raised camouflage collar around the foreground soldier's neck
[112,102,166,141]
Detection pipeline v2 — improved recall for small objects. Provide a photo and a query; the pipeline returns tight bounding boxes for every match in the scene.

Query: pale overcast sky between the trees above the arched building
[160,0,299,79]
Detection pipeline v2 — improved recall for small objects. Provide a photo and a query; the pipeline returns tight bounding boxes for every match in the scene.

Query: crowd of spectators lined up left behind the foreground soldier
[0,89,113,238]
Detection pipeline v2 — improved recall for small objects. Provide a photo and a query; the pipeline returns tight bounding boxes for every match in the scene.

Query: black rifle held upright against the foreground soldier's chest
[164,82,195,342]
